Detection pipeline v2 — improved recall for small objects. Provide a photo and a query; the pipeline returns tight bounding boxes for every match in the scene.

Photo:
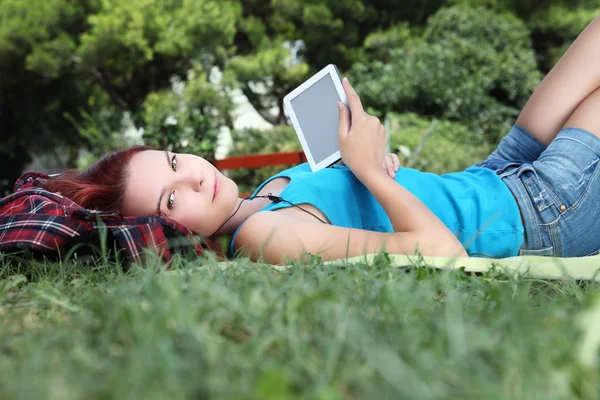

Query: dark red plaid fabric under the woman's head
[0,173,204,264]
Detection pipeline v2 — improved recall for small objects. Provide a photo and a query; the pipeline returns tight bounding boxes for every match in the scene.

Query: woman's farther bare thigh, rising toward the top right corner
[516,17,600,146]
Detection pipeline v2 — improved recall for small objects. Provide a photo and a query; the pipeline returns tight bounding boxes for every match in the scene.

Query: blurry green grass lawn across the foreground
[0,253,600,400]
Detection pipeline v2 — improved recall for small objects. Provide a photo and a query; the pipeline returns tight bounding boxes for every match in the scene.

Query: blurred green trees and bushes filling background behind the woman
[0,0,600,193]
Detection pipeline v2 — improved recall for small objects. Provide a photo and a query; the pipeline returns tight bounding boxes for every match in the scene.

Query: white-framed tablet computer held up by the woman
[283,64,348,172]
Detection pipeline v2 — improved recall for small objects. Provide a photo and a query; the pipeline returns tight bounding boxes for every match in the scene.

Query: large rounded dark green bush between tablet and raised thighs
[352,6,541,143]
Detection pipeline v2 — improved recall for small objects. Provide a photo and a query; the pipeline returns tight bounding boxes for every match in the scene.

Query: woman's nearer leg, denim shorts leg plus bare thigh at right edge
[507,88,600,257]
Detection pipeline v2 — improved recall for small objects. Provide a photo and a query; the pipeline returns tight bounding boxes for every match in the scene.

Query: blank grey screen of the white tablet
[290,74,341,163]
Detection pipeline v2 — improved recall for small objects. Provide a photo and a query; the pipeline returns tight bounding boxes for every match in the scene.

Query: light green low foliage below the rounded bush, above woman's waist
[389,113,494,174]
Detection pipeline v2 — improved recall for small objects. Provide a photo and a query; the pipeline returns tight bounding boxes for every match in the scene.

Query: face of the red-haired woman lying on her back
[122,150,238,236]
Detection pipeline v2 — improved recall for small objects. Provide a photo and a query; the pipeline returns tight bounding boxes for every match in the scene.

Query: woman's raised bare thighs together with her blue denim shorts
[480,17,600,257]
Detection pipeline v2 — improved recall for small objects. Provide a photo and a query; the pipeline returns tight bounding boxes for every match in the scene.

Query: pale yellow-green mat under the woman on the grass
[262,254,600,281]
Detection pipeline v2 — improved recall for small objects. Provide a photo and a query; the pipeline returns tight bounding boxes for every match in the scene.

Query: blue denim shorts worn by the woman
[475,125,600,257]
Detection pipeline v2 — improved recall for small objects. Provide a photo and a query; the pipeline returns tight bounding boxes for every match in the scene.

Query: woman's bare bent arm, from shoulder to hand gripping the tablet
[236,79,467,264]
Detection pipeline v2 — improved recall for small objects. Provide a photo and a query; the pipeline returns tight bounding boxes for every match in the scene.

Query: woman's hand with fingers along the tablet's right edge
[338,78,387,179]
